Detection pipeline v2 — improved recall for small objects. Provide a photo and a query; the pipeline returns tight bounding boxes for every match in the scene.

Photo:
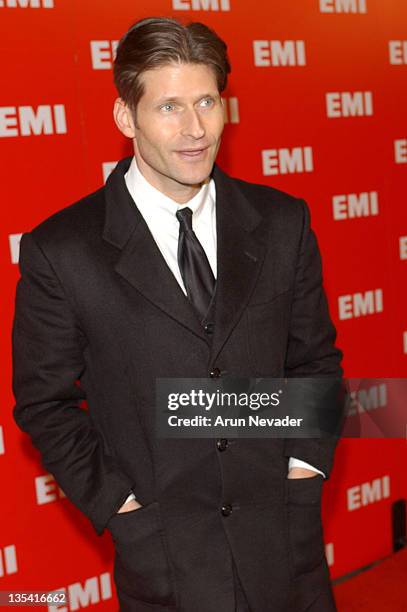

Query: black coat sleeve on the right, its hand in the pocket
[284,200,343,478]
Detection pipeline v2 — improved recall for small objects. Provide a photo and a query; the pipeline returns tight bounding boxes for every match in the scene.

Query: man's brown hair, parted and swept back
[113,17,230,116]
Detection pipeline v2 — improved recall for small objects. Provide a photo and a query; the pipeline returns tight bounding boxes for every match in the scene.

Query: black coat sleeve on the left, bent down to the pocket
[12,233,132,534]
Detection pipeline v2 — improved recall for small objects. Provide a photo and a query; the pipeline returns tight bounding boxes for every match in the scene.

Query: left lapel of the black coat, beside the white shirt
[103,157,208,342]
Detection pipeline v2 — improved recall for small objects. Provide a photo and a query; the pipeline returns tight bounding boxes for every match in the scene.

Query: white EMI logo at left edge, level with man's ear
[0,104,67,138]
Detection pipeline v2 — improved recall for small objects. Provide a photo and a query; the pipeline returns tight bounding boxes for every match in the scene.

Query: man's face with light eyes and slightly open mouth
[134,64,224,199]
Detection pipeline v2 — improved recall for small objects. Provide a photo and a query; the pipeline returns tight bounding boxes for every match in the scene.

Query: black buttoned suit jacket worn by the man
[13,158,341,612]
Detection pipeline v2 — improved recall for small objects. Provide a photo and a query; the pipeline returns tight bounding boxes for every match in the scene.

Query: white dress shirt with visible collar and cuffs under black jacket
[124,157,325,503]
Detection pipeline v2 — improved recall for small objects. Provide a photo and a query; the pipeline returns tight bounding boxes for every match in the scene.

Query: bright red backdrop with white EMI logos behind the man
[0,0,407,610]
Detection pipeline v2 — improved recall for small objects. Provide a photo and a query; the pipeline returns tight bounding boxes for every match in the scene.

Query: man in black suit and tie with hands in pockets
[13,19,341,612]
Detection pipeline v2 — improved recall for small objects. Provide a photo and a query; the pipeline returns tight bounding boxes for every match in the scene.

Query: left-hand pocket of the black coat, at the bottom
[107,502,175,604]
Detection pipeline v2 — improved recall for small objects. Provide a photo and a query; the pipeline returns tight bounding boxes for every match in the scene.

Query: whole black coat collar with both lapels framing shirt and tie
[103,157,265,363]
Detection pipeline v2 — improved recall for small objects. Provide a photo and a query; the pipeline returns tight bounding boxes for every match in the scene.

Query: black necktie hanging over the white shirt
[176,208,215,321]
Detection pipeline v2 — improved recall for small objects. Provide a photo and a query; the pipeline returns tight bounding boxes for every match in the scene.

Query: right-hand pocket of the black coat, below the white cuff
[286,474,325,578]
